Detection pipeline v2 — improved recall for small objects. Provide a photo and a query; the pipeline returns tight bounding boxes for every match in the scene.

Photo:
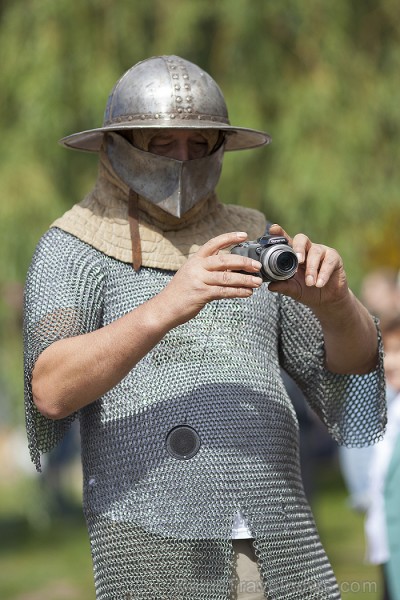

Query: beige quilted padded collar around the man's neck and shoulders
[52,151,266,271]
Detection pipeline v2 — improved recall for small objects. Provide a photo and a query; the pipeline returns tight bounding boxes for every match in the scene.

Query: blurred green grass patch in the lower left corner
[0,477,95,600]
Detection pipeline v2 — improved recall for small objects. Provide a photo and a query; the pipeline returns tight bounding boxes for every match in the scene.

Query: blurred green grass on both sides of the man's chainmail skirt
[0,463,380,600]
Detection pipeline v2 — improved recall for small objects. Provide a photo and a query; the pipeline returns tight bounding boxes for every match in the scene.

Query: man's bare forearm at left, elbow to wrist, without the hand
[32,297,179,419]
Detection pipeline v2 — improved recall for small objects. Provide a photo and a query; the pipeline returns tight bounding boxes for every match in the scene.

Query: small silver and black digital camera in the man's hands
[231,235,299,281]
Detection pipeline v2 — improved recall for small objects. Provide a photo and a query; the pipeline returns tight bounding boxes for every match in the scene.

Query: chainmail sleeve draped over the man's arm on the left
[24,228,103,470]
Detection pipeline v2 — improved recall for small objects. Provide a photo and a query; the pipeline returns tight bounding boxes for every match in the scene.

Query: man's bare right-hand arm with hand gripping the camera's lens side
[269,225,378,374]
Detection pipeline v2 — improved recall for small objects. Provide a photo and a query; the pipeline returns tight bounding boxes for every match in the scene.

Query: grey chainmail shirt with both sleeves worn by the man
[24,228,385,600]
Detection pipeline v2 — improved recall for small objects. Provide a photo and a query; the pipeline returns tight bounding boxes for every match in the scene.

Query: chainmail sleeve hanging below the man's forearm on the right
[280,296,386,447]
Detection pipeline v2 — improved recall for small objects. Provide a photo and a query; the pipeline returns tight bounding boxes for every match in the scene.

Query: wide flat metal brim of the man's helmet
[59,120,272,152]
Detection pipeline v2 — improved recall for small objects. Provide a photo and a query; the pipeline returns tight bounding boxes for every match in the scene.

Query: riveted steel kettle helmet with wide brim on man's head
[60,56,271,152]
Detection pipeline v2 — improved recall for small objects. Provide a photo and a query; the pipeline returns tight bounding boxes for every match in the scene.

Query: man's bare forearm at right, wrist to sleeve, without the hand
[313,291,378,375]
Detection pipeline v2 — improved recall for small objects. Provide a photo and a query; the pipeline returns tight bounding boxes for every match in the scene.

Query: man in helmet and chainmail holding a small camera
[25,56,385,600]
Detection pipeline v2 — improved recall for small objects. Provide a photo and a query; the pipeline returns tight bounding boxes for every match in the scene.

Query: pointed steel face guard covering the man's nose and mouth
[105,133,224,218]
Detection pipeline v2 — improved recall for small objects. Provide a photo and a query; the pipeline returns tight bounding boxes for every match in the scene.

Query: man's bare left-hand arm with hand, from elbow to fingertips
[32,233,261,419]
